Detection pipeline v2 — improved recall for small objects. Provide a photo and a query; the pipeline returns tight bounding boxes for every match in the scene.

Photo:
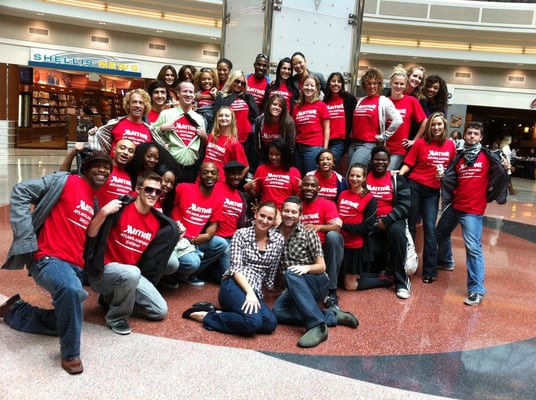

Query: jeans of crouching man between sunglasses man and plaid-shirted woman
[177,236,229,282]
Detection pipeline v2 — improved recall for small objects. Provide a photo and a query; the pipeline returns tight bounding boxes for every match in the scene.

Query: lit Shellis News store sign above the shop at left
[29,48,141,78]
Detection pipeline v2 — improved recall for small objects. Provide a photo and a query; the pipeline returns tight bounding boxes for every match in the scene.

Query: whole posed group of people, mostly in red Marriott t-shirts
[0,52,510,374]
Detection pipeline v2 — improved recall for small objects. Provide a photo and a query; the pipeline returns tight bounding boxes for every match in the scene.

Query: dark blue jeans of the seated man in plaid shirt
[272,270,337,330]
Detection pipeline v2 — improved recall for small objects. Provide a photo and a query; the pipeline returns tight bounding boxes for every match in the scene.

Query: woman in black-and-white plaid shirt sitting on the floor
[182,202,284,335]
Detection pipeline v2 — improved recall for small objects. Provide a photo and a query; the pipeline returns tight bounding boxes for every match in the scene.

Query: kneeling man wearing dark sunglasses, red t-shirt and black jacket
[86,172,179,335]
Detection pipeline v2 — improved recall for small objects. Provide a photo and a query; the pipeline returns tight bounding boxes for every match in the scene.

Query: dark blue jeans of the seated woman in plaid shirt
[203,277,277,335]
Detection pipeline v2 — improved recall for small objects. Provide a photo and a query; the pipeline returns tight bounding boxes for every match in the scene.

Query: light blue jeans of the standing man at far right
[437,206,486,294]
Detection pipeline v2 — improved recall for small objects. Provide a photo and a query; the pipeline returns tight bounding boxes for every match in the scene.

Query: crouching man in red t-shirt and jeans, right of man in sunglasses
[171,162,228,286]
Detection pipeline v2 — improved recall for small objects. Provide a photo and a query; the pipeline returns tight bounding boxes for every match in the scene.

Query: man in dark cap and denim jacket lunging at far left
[0,151,114,374]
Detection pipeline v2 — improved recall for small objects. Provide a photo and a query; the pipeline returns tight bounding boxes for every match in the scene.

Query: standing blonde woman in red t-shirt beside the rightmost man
[400,112,456,283]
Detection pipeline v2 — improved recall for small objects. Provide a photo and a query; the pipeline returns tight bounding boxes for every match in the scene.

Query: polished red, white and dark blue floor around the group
[0,150,536,399]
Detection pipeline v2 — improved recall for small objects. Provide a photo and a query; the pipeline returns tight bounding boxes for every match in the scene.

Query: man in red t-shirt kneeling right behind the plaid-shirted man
[301,175,344,309]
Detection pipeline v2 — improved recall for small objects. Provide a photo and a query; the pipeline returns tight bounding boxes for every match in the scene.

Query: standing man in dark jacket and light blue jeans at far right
[436,121,510,306]
